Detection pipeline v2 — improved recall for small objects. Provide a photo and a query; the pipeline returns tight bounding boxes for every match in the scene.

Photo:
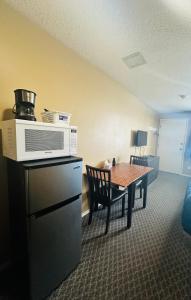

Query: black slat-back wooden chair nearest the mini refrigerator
[86,165,127,234]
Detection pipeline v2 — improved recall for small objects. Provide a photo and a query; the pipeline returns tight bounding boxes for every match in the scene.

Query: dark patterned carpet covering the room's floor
[49,173,191,300]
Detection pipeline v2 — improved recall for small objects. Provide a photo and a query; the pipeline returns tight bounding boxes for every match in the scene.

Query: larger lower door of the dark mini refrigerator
[28,197,81,300]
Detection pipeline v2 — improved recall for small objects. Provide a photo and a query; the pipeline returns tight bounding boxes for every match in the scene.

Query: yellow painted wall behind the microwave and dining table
[0,1,158,264]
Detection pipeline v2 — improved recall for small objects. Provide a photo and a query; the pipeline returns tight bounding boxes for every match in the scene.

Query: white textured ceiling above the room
[6,0,191,113]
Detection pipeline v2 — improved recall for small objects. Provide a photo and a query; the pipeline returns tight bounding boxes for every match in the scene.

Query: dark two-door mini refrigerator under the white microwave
[7,157,82,300]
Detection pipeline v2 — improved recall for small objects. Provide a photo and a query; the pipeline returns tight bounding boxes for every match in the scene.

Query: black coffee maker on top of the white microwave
[13,89,36,121]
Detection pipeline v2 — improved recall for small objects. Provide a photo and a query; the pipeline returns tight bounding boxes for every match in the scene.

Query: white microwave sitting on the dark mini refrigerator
[2,119,77,161]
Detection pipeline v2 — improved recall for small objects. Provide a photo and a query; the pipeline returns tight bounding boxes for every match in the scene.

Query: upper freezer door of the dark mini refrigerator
[27,162,82,215]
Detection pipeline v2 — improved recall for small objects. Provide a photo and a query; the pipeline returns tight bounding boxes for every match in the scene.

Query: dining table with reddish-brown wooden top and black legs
[111,163,153,228]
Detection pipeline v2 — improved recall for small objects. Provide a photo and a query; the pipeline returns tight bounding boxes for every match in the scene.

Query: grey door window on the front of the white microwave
[25,129,64,152]
